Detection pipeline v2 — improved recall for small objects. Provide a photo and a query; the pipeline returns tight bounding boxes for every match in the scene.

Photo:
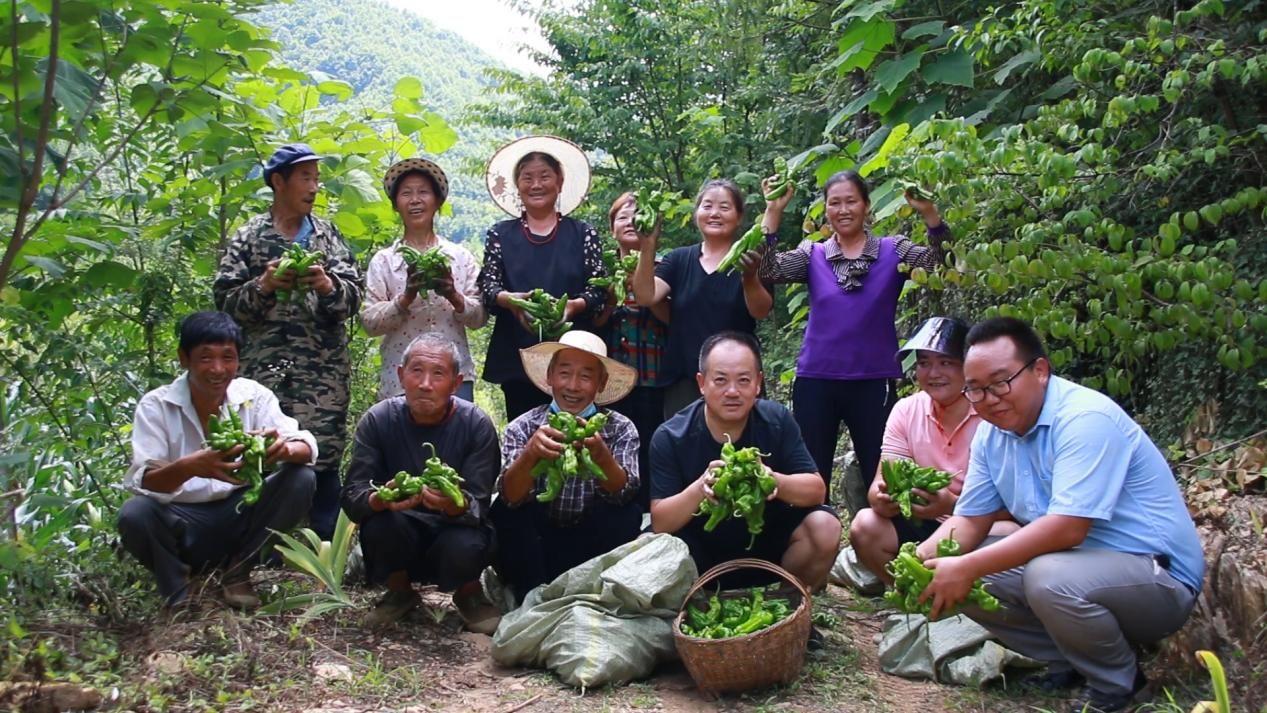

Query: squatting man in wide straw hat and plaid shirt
[490,329,642,598]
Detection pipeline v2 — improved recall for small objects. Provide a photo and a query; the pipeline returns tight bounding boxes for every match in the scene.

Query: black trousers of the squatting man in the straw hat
[489,496,642,598]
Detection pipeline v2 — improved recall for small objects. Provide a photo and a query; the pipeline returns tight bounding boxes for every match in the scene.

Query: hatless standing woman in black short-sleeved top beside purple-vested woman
[634,179,774,419]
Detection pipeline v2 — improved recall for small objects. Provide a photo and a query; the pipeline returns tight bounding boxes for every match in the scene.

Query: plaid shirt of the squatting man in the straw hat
[497,404,639,527]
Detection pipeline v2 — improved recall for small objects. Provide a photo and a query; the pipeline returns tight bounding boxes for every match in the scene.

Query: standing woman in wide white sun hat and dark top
[479,136,607,419]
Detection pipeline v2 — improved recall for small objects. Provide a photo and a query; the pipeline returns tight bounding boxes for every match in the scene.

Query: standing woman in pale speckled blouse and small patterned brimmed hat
[361,158,488,401]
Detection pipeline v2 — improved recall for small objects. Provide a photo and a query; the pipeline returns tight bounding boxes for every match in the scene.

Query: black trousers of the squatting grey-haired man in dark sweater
[361,510,493,591]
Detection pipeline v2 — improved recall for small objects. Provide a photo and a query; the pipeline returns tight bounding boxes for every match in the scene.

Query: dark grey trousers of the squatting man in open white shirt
[118,464,317,605]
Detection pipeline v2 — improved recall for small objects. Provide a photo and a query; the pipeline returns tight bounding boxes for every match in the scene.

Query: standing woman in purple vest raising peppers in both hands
[760,171,949,512]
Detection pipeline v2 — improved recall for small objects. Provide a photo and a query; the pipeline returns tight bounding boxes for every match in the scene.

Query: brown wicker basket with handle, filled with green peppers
[673,558,811,694]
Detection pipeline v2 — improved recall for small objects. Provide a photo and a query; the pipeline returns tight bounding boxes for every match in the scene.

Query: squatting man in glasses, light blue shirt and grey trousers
[920,318,1205,712]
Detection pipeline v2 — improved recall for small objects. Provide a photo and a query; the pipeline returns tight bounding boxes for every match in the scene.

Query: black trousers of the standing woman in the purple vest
[792,376,897,514]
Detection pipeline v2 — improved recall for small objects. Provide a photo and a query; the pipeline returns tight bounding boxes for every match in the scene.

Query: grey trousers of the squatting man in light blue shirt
[963,550,1196,694]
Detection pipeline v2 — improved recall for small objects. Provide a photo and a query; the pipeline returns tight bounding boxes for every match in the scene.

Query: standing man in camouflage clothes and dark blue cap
[213,143,364,539]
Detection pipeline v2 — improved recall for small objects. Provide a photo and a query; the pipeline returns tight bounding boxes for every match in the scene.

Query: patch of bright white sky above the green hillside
[386,0,557,73]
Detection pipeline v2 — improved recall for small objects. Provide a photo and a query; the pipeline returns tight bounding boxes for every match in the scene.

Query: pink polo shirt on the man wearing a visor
[881,391,981,495]
